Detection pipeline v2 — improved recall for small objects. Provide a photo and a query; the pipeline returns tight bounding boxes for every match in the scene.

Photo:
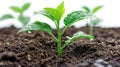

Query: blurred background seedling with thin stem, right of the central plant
[82,5,103,35]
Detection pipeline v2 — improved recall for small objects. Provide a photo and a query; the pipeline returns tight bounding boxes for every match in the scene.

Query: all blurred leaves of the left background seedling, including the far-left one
[0,3,31,26]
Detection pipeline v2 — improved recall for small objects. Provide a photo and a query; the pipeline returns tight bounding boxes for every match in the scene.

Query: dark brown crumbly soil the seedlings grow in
[0,27,120,67]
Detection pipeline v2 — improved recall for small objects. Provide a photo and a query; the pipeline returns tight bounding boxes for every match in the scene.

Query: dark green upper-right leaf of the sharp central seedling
[64,11,88,27]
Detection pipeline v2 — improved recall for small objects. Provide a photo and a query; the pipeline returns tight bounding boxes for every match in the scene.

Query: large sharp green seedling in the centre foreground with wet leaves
[18,2,94,57]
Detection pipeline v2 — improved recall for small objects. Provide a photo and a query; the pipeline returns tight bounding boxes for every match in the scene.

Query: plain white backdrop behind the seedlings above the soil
[0,0,120,28]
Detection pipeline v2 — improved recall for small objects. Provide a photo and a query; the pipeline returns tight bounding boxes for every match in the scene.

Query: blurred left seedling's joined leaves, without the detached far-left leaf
[10,3,30,26]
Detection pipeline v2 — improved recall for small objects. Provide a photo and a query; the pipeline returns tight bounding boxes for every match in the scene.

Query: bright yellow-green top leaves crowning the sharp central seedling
[35,2,65,22]
